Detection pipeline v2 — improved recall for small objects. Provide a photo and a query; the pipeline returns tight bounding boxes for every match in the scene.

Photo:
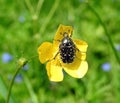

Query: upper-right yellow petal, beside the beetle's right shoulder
[74,39,88,53]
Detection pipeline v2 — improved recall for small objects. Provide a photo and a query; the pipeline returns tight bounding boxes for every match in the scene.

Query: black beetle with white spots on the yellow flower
[59,33,76,63]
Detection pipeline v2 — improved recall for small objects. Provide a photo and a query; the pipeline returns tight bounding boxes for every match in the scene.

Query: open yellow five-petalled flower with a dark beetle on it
[38,25,88,82]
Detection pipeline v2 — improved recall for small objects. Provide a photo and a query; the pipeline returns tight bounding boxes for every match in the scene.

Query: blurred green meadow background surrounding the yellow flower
[0,0,120,103]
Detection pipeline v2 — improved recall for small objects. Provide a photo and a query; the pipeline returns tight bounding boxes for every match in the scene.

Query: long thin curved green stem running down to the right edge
[86,2,120,65]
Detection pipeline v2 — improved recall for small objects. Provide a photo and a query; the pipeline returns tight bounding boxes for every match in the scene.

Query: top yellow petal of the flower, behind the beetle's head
[53,24,73,47]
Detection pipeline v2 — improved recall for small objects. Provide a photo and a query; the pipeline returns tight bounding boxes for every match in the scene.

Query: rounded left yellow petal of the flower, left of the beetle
[38,42,57,63]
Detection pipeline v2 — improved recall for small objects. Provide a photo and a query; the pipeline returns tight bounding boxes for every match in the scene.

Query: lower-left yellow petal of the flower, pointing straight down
[46,59,63,82]
